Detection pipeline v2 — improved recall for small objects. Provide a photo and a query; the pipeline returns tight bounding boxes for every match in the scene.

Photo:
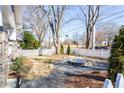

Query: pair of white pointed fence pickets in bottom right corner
[103,73,124,88]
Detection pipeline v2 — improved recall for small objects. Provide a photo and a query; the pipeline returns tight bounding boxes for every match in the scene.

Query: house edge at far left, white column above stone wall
[0,5,21,88]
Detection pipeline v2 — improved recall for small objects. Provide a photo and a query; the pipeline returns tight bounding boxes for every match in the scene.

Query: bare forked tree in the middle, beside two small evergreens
[40,5,66,54]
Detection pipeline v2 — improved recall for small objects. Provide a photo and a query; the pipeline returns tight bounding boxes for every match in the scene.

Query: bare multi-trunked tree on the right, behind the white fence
[80,5,100,48]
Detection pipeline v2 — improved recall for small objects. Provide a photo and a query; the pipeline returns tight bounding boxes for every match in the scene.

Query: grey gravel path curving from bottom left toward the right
[20,60,107,88]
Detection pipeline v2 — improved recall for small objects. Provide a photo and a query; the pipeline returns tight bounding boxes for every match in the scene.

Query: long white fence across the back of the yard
[18,48,110,59]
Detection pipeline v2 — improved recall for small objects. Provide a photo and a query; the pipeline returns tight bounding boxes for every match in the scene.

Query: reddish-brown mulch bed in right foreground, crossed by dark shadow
[65,71,107,88]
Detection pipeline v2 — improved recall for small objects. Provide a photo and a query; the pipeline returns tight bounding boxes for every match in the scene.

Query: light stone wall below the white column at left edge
[0,31,18,88]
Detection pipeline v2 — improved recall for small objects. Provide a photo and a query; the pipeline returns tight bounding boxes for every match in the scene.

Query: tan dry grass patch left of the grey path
[24,55,80,80]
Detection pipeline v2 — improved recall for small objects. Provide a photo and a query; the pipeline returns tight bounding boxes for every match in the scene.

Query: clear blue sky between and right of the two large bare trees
[22,5,124,41]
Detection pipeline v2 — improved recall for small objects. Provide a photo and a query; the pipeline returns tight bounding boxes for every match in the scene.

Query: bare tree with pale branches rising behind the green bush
[24,6,48,43]
